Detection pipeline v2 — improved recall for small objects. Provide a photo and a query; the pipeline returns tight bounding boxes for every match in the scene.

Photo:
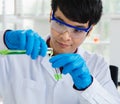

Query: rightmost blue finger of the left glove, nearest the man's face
[39,37,48,57]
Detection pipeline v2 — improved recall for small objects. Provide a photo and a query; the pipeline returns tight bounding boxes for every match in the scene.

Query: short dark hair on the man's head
[51,0,103,25]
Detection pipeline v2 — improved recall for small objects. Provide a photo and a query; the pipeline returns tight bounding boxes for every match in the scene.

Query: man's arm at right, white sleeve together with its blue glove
[50,54,120,104]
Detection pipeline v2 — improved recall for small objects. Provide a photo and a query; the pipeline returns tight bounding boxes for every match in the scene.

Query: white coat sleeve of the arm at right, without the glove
[78,55,120,104]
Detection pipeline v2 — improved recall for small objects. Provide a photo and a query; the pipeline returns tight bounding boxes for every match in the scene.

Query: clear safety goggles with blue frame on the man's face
[51,13,91,38]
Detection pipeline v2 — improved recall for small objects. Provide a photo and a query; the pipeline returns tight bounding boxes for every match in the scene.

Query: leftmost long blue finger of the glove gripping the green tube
[26,30,35,55]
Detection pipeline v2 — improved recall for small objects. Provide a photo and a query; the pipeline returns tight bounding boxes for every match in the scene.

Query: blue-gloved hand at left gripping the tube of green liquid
[4,30,47,59]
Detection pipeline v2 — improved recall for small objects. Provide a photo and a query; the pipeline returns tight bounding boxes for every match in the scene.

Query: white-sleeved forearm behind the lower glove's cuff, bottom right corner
[77,78,120,104]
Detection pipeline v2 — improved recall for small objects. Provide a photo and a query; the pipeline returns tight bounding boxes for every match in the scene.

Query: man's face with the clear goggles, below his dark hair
[50,8,90,54]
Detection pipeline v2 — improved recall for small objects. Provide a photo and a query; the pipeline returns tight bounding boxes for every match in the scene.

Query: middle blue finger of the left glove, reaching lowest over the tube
[31,36,40,59]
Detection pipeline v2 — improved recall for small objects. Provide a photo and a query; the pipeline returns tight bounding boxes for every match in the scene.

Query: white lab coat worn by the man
[0,31,120,104]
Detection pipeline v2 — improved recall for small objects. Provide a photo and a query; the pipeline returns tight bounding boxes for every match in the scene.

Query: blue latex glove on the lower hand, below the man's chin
[50,53,92,89]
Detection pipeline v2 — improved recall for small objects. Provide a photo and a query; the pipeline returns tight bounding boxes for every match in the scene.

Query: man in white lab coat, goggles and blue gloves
[0,0,120,104]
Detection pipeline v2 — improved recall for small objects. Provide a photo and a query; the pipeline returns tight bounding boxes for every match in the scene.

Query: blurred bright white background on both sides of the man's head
[0,0,120,90]
